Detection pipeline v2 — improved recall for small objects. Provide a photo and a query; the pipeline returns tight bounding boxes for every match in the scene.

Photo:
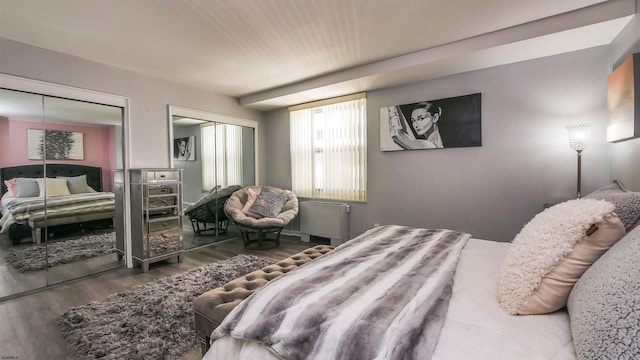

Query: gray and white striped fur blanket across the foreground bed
[211,225,470,360]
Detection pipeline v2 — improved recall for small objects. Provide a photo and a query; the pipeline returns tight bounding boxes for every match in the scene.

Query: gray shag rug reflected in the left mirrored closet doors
[4,232,116,273]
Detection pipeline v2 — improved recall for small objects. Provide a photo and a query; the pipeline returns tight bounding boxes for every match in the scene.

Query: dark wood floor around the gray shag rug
[0,235,315,360]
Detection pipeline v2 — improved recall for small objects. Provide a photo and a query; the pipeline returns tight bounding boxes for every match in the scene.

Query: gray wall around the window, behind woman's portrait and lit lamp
[265,47,611,241]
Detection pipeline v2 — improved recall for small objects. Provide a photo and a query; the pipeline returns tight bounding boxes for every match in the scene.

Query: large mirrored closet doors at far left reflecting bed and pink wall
[0,75,125,299]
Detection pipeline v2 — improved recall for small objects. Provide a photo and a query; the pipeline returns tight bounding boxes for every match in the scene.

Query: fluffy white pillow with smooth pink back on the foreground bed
[498,199,625,315]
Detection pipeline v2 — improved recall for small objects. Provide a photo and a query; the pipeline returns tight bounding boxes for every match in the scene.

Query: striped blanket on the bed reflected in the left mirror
[0,192,115,233]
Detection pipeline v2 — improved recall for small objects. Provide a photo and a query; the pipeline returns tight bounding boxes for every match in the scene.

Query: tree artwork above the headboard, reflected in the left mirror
[27,129,84,160]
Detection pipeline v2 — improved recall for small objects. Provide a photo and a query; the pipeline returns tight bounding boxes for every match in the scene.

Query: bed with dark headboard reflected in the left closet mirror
[0,164,115,244]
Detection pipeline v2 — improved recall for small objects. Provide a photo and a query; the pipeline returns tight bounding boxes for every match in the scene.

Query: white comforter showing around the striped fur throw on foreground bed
[204,239,576,360]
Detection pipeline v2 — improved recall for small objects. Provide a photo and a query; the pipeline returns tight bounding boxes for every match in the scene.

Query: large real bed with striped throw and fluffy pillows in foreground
[204,182,640,360]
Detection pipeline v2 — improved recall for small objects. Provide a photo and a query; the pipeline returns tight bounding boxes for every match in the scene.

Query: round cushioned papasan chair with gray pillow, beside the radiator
[224,186,298,250]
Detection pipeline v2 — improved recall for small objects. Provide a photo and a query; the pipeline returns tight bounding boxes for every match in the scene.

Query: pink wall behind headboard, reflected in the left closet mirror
[0,117,116,191]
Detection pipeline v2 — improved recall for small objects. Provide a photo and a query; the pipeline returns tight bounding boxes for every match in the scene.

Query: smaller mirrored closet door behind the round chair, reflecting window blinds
[169,106,258,250]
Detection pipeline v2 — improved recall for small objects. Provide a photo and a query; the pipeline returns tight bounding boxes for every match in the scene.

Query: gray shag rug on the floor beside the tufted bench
[57,255,273,360]
